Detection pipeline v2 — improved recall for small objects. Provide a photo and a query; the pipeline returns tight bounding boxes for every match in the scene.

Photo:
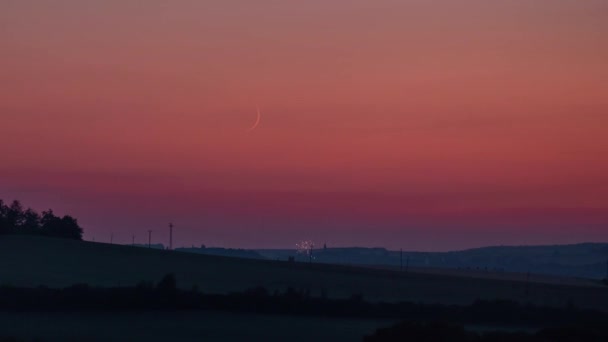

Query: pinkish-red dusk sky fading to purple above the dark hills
[0,0,608,251]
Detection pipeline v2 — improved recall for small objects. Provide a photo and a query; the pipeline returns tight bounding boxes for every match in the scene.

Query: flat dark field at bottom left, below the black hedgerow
[0,312,391,342]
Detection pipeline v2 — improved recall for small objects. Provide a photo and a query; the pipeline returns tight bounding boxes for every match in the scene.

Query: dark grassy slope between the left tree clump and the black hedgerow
[0,236,608,309]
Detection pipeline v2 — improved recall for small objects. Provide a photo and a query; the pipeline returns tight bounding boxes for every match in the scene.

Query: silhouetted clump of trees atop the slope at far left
[0,199,82,240]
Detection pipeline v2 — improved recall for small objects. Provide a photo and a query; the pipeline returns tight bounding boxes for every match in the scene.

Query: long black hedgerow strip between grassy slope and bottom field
[0,274,608,332]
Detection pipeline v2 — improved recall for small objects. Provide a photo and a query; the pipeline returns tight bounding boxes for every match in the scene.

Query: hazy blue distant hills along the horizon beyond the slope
[178,243,608,279]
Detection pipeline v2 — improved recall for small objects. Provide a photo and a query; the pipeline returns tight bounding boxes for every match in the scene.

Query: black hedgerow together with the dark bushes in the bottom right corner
[0,274,608,342]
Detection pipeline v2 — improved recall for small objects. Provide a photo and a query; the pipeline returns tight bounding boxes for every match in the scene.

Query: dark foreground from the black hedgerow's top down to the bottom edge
[0,275,608,342]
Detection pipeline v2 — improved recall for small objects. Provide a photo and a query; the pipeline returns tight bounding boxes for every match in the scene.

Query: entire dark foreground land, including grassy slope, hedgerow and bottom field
[0,237,608,342]
